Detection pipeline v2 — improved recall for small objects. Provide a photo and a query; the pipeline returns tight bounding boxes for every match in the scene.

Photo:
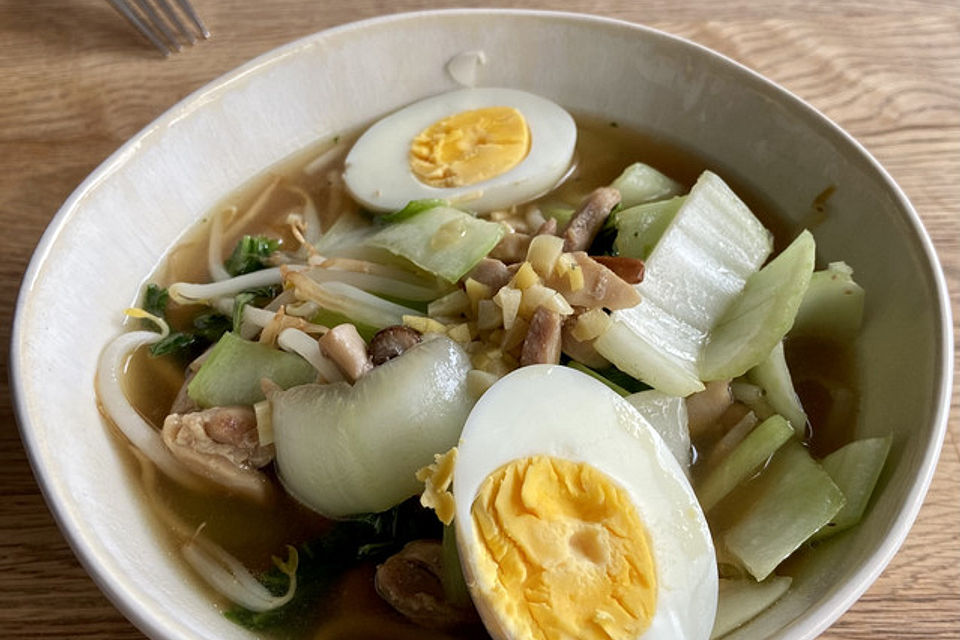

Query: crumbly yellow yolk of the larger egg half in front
[471,456,657,640]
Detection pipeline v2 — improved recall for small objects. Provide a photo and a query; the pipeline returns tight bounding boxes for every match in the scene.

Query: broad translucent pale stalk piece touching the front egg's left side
[269,337,474,518]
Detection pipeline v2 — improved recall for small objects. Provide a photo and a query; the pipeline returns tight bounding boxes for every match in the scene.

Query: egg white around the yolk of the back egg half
[343,87,577,213]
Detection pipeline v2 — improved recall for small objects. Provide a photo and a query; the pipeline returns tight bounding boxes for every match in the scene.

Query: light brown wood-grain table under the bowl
[0,0,960,640]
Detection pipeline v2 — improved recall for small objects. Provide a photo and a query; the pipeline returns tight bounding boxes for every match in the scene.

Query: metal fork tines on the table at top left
[107,0,210,56]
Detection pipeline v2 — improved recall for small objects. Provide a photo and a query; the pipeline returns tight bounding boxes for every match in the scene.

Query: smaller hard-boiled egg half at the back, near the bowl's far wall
[343,87,577,213]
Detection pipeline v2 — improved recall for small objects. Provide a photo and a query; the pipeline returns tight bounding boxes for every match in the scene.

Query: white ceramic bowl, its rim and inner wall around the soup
[11,11,952,640]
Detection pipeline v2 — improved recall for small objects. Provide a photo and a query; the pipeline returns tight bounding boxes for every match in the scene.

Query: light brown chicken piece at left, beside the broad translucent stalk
[162,406,274,502]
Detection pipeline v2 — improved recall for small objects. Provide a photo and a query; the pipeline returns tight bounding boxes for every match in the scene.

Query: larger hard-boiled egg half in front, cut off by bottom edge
[453,365,717,640]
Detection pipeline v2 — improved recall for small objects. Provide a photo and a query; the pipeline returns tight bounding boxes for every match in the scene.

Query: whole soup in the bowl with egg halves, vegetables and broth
[97,89,889,640]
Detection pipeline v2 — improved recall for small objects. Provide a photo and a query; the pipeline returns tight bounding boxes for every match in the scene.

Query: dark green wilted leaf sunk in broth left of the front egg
[224,498,442,638]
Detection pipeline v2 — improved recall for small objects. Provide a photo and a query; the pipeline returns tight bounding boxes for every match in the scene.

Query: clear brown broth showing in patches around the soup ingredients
[116,117,856,638]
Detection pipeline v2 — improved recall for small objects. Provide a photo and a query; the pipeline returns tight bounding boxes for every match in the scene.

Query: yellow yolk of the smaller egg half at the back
[409,107,530,188]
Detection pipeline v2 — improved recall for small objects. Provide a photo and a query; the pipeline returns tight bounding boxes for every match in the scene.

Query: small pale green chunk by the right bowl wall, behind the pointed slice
[790,262,864,342]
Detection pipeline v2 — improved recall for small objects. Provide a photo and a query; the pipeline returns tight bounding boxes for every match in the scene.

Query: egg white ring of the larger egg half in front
[453,365,718,640]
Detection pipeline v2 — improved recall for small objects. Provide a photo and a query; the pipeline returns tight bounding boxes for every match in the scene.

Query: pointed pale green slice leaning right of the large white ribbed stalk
[700,230,816,380]
